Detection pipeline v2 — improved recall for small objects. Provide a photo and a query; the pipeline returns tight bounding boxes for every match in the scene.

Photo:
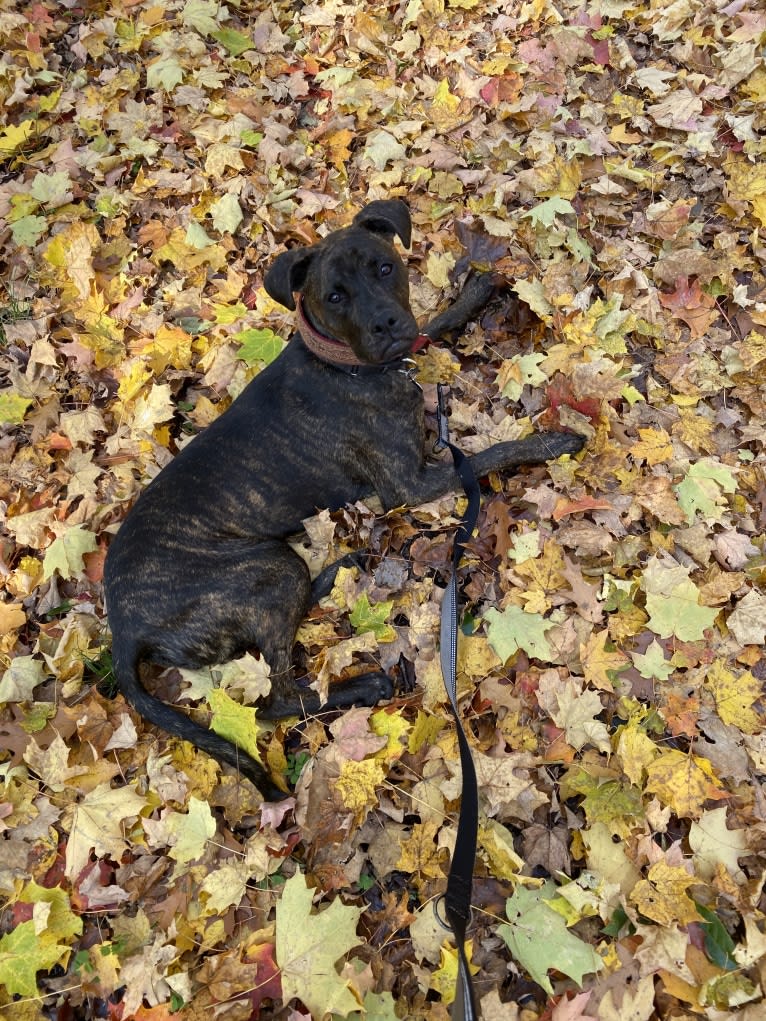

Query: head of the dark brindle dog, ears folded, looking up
[264,199,418,364]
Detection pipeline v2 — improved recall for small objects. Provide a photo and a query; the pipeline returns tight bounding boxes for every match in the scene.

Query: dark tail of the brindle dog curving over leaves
[112,638,285,800]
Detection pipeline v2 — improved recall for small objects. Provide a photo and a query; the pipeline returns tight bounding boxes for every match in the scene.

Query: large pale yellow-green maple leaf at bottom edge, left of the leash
[276,872,362,1017]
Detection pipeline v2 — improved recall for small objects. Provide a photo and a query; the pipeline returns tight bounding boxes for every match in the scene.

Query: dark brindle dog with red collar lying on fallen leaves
[104,199,583,799]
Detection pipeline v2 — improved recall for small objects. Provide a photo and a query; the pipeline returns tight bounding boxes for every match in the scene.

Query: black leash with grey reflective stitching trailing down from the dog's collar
[436,383,481,1021]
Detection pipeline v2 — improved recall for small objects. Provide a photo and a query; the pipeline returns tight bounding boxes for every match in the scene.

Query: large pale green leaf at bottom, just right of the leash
[497,883,604,995]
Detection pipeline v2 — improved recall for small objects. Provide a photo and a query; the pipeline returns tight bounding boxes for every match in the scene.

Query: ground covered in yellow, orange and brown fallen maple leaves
[0,0,766,1021]
